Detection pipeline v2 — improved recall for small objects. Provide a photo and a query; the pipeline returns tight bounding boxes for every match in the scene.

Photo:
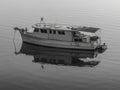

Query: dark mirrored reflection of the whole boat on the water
[16,43,103,67]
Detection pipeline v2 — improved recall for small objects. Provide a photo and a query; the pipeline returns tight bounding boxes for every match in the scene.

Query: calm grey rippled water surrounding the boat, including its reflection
[0,0,120,90]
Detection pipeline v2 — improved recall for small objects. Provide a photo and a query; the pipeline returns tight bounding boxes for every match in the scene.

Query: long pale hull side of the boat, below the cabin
[21,33,97,50]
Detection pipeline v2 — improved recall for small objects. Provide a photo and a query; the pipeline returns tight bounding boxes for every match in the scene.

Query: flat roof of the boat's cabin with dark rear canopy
[32,23,99,33]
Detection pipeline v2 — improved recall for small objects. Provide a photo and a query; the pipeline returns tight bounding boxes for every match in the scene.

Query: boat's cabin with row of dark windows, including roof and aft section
[28,23,99,43]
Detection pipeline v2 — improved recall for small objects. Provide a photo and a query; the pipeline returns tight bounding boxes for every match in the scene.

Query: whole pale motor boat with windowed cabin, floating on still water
[14,18,106,50]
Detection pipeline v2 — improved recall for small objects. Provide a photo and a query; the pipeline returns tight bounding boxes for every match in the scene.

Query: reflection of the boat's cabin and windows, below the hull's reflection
[33,56,99,67]
